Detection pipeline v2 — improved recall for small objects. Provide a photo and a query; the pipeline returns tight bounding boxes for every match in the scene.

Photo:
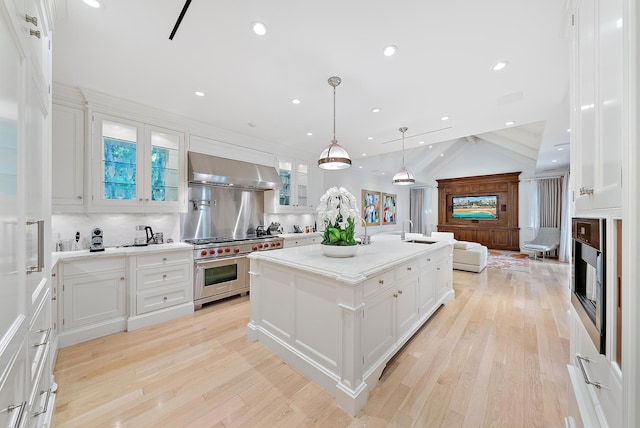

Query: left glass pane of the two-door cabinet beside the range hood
[102,120,138,200]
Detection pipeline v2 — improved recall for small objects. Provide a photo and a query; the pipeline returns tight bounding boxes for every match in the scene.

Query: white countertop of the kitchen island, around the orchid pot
[249,233,450,284]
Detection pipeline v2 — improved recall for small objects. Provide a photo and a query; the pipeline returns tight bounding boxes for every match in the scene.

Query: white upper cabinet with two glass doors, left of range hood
[89,113,186,213]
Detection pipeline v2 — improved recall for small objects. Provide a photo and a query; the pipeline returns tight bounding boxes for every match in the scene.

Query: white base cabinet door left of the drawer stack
[58,256,127,347]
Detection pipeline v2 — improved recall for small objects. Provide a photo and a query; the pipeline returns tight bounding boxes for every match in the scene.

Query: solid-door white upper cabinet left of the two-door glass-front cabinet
[51,104,85,212]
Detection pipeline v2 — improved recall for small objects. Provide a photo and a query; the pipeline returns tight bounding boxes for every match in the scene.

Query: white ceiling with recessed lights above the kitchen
[53,0,570,181]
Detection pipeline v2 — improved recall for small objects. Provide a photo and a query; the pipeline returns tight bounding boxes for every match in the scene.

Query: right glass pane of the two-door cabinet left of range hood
[150,131,180,202]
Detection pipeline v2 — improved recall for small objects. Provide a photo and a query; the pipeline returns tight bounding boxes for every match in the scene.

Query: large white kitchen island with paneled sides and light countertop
[247,235,454,415]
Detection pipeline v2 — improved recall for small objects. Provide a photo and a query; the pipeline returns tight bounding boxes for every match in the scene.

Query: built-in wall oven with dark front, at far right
[571,218,607,354]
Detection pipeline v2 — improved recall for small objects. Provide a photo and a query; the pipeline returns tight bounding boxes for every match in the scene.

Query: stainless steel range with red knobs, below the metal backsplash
[184,235,284,310]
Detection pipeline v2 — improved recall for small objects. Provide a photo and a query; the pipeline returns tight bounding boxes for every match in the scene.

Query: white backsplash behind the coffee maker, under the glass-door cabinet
[51,214,180,251]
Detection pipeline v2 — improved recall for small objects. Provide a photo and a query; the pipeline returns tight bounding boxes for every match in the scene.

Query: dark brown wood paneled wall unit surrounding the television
[437,172,520,251]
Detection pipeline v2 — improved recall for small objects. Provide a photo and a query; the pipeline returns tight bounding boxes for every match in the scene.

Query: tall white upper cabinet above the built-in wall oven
[571,0,628,214]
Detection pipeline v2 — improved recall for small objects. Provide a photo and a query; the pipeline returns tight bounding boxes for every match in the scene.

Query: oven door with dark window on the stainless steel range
[193,256,249,309]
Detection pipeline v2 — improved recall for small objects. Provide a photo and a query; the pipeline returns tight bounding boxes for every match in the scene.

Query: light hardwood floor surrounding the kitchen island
[54,260,570,427]
